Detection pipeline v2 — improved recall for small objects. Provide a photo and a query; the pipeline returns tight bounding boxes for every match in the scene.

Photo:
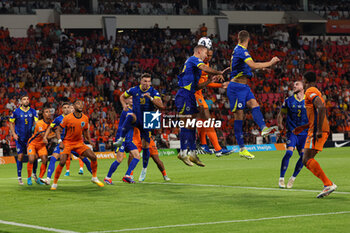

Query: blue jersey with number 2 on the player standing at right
[281,95,309,135]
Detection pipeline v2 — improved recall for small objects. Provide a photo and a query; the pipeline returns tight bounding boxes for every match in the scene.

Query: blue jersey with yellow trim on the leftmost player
[10,107,38,142]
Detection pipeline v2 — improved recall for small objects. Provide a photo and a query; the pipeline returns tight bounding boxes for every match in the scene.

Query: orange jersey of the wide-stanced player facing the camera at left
[60,113,89,144]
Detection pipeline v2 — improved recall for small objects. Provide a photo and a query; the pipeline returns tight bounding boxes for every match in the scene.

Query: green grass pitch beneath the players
[0,147,350,233]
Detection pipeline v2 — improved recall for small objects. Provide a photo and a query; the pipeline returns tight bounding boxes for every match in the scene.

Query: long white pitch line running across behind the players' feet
[0,177,350,195]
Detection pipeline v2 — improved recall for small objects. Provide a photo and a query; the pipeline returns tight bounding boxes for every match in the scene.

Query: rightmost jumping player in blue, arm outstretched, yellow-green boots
[227,30,280,159]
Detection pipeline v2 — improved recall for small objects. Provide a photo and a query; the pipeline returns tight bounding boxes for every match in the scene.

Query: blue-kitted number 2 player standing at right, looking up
[277,81,309,188]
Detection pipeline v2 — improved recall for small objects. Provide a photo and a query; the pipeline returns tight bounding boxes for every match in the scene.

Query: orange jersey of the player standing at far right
[305,87,329,136]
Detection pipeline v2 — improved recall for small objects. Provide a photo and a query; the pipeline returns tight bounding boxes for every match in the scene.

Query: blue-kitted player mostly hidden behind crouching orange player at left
[42,102,91,185]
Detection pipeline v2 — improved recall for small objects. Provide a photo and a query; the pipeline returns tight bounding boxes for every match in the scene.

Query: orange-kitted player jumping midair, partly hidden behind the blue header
[194,48,231,157]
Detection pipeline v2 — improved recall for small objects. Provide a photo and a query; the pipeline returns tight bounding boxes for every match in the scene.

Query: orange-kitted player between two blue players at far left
[27,106,51,185]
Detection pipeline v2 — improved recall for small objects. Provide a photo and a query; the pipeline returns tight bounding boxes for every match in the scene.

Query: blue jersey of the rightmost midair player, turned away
[230,44,253,79]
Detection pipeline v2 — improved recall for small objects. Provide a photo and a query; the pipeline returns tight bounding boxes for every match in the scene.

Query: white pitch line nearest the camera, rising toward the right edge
[89,211,350,233]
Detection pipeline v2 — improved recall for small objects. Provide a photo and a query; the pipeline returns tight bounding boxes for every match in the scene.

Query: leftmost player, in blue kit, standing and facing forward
[10,95,38,185]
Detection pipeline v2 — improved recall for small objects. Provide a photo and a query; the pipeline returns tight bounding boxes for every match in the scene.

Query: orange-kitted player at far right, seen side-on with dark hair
[294,72,337,198]
